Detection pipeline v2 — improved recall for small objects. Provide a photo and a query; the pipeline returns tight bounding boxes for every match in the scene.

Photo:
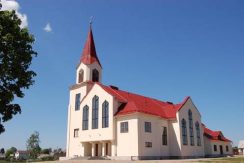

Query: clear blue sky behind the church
[0,0,244,149]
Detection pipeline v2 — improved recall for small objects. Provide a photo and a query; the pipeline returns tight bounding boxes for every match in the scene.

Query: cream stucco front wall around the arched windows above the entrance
[67,84,114,157]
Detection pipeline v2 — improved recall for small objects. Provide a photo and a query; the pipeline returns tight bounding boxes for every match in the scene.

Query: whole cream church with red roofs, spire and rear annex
[66,27,232,160]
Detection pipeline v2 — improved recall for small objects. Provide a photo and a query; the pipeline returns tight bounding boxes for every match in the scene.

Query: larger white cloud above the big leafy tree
[1,0,28,28]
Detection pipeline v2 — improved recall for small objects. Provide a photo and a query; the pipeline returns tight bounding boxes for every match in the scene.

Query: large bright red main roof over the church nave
[97,83,190,118]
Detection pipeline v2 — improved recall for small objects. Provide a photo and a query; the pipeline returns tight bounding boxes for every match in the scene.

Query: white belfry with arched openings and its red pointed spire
[76,24,102,84]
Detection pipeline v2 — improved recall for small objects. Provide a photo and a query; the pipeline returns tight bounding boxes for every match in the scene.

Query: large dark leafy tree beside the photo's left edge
[0,11,37,134]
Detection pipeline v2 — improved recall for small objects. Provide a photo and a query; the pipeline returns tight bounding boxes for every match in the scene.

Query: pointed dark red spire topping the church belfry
[80,24,102,67]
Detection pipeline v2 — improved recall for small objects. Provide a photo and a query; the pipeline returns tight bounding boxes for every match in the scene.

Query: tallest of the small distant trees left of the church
[26,131,41,159]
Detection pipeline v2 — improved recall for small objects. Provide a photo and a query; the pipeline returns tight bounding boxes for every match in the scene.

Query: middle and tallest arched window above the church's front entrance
[92,96,99,129]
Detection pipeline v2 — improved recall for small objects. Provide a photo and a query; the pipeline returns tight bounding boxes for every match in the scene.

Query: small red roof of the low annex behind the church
[202,124,231,142]
